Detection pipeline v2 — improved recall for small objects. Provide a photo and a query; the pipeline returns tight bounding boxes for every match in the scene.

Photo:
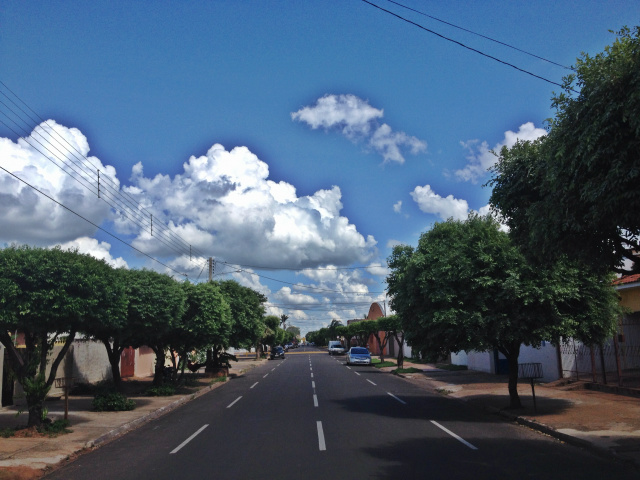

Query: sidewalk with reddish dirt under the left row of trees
[0,360,266,480]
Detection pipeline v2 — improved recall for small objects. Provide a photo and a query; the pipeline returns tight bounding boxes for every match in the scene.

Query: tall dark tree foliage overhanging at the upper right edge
[489,27,640,272]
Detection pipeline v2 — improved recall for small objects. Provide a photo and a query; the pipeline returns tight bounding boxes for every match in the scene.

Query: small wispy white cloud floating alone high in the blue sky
[291,94,427,163]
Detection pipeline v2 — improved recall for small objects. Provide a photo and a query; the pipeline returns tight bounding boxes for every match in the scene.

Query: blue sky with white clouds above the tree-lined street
[0,0,640,333]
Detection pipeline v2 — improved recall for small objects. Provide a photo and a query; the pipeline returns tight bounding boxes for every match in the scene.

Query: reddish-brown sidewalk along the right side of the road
[383,361,640,468]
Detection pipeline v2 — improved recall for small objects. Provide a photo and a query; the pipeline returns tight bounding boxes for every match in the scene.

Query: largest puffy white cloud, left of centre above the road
[125,144,376,267]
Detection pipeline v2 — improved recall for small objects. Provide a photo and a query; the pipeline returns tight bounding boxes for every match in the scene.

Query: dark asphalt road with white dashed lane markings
[46,347,637,480]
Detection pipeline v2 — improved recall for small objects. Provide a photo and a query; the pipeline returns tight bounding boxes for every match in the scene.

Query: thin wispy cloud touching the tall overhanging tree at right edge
[455,122,547,183]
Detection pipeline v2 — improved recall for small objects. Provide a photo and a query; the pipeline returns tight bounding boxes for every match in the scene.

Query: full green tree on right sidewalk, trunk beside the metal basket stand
[387,216,620,408]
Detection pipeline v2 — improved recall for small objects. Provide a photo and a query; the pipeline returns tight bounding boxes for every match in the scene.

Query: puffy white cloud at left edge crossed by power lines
[0,120,119,246]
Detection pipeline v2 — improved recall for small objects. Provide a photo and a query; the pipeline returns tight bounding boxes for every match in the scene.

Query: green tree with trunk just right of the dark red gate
[125,270,186,386]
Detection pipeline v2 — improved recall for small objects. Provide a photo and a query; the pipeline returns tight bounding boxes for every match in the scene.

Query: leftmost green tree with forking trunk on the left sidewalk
[0,246,126,426]
